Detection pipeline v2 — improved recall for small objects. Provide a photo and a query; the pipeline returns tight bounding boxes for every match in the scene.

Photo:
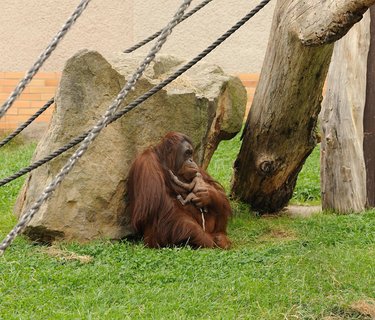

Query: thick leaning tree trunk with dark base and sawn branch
[232,0,375,212]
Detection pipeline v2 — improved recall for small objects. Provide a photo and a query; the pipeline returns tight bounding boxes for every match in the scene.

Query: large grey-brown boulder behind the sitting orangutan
[16,50,246,242]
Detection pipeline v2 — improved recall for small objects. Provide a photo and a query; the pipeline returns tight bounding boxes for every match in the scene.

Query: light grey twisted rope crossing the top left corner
[0,0,91,119]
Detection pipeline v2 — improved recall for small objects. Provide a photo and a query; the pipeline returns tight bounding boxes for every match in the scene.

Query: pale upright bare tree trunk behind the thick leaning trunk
[321,13,370,213]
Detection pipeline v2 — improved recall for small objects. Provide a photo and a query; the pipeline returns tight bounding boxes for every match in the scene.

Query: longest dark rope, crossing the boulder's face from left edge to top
[0,0,271,187]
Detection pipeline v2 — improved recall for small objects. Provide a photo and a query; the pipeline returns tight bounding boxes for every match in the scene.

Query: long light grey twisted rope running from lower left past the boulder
[0,0,192,256]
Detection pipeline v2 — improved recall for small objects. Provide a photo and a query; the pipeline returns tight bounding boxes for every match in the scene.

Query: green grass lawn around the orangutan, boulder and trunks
[0,138,375,320]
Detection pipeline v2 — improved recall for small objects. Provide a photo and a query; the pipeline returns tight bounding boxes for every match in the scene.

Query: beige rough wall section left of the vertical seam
[0,0,133,72]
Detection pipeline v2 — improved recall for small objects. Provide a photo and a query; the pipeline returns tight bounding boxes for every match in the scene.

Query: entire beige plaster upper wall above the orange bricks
[0,0,275,73]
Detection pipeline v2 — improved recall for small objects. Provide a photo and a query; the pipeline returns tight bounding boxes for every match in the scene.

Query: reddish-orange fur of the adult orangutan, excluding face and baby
[127,132,231,248]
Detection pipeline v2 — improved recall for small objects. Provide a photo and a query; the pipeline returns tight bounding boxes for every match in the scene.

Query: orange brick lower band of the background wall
[0,72,259,132]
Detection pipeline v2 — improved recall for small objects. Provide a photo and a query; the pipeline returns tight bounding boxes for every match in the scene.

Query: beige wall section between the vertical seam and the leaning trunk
[133,0,275,74]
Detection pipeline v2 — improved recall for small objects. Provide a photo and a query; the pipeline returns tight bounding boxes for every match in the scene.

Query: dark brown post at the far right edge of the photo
[363,7,375,207]
